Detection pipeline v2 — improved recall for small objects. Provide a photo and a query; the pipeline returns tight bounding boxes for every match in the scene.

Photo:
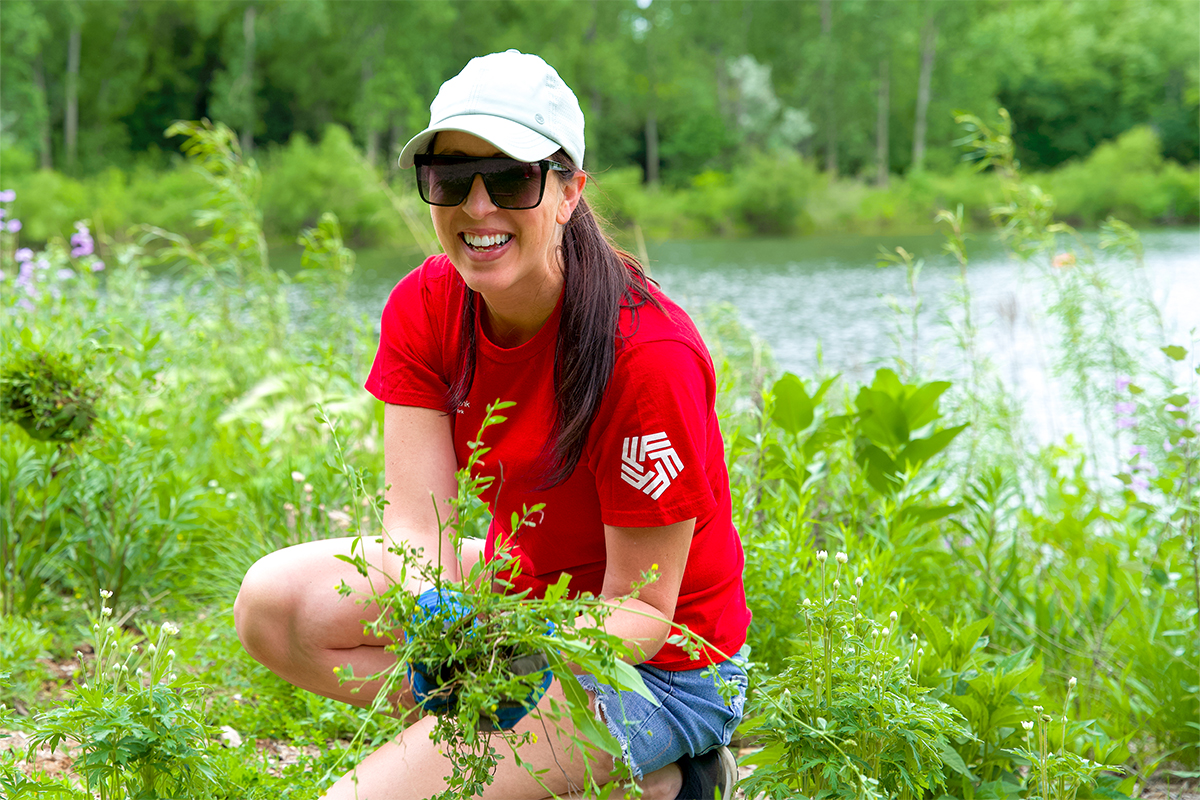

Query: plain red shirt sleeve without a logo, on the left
[365,260,458,409]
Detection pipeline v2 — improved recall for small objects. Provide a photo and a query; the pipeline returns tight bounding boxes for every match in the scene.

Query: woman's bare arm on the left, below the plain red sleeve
[383,403,460,593]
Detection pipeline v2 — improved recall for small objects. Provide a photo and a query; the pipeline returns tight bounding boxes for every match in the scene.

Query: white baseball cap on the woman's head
[400,50,583,169]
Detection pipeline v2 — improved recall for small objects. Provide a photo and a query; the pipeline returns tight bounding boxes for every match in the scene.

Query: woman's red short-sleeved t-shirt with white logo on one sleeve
[366,255,750,670]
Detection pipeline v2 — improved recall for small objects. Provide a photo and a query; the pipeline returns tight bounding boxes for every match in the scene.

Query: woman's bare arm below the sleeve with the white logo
[581,518,696,663]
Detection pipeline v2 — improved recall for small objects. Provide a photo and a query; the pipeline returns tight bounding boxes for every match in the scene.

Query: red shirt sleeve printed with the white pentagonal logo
[587,341,716,528]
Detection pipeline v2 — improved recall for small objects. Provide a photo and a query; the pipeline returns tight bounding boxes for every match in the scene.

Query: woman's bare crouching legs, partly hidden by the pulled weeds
[234,539,679,800]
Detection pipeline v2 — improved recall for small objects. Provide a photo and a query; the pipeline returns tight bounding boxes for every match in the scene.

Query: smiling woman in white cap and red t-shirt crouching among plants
[235,50,750,800]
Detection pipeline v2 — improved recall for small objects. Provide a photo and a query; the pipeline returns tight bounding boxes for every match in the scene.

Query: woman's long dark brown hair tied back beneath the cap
[446,150,662,489]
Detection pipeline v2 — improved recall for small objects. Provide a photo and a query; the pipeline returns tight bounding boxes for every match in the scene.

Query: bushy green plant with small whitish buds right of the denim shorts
[740,551,971,798]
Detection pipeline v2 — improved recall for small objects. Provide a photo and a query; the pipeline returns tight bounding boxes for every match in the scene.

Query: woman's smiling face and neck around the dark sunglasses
[430,131,587,345]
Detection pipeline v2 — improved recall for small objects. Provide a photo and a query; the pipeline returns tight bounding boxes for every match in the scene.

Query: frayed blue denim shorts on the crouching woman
[576,645,750,778]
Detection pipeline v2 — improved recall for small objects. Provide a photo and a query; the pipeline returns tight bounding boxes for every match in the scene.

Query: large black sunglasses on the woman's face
[413,154,571,211]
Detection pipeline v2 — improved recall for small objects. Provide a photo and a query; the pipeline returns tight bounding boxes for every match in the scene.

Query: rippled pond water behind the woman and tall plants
[319,229,1200,439]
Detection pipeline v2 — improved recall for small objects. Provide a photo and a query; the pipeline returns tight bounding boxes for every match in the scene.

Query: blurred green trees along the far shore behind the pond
[0,0,1200,243]
